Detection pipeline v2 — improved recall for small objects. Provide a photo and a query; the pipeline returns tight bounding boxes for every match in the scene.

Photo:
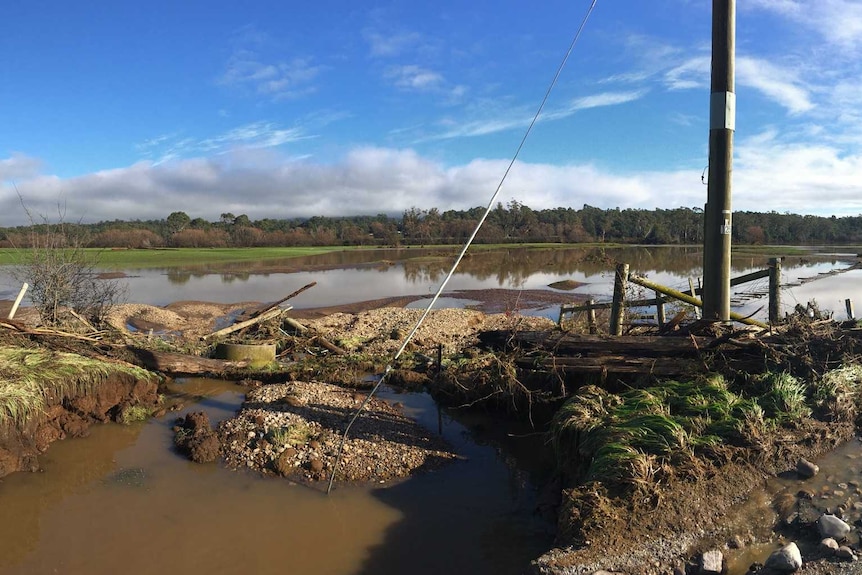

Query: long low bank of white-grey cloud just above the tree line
[0,133,862,225]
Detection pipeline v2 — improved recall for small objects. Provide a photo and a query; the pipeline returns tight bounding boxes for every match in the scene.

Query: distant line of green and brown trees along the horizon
[0,201,862,248]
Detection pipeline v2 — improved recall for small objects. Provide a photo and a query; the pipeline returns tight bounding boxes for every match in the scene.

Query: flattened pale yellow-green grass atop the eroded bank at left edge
[0,346,153,426]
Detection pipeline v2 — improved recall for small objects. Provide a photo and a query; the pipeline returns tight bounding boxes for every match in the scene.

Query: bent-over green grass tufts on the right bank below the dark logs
[551,368,836,487]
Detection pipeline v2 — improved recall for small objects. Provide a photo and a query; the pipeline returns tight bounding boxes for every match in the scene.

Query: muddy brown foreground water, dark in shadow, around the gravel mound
[0,380,552,575]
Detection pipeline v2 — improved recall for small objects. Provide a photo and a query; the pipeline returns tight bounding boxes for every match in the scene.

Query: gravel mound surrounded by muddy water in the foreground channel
[218,381,457,483]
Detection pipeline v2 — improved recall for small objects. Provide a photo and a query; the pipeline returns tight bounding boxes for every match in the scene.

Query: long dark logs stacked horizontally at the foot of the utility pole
[479,314,862,387]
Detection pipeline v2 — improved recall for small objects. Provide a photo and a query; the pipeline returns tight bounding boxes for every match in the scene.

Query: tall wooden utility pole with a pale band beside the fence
[703,0,736,321]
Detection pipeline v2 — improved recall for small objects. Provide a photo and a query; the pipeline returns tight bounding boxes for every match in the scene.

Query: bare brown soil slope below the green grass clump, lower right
[532,420,855,575]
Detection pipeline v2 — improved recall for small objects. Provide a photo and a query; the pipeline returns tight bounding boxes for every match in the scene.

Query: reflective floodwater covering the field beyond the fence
[0,246,862,319]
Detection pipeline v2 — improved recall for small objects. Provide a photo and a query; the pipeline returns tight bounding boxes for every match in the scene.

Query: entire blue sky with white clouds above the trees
[0,0,862,226]
